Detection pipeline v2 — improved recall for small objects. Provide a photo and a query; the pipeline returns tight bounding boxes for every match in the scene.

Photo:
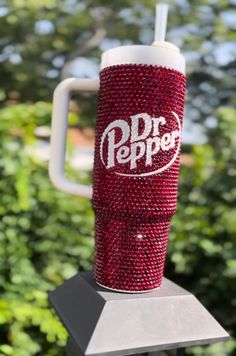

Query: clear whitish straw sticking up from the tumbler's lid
[154,3,168,42]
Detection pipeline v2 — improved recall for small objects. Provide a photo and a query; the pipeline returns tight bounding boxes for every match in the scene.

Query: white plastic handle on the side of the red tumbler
[49,78,99,198]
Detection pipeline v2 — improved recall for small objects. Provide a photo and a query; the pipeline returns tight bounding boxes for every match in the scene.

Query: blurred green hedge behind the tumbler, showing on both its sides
[0,102,236,356]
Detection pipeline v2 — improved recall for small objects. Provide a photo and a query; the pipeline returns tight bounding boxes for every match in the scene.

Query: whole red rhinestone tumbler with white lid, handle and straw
[49,5,186,293]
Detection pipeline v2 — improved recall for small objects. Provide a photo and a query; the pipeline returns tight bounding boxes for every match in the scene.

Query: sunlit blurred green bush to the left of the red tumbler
[0,102,93,356]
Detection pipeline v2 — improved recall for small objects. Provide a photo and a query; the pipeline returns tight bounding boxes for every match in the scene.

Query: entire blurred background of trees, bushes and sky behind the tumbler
[0,0,236,356]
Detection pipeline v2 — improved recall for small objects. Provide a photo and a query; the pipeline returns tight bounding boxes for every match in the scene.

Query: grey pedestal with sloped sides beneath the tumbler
[49,272,229,356]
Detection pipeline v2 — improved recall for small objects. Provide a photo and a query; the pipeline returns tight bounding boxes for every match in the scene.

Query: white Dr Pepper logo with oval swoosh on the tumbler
[100,111,181,177]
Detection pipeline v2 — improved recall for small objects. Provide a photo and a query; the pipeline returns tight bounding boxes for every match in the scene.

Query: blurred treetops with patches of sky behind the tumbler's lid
[0,0,236,125]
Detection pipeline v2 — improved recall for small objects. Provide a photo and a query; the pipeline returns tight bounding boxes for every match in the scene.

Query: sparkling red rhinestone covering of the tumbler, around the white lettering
[92,64,186,292]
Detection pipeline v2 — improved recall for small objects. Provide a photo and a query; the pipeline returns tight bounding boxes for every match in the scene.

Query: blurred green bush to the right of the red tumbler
[166,107,236,356]
